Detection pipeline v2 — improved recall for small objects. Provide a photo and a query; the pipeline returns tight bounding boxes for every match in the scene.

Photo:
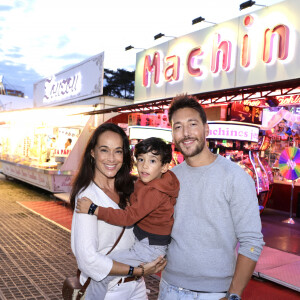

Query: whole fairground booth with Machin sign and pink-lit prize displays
[88,0,300,218]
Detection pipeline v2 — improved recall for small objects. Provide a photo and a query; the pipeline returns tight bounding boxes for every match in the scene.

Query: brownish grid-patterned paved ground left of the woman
[0,174,159,300]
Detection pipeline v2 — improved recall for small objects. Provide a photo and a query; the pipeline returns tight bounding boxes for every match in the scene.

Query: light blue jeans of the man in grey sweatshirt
[158,279,225,300]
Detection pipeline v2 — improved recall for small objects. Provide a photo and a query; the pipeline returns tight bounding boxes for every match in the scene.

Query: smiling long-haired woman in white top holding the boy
[71,123,166,300]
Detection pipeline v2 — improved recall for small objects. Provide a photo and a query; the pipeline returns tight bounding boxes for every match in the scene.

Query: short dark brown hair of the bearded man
[169,95,207,124]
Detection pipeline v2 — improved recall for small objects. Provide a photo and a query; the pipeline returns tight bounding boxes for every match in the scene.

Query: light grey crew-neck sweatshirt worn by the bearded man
[162,155,264,292]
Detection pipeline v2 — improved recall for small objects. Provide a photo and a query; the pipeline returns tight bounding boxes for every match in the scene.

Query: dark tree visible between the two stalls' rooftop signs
[103,69,135,99]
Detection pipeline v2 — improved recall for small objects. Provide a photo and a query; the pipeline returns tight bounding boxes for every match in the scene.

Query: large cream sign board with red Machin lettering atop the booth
[135,0,300,102]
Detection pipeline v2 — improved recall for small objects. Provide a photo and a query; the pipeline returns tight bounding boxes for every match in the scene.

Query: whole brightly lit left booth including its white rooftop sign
[0,53,132,193]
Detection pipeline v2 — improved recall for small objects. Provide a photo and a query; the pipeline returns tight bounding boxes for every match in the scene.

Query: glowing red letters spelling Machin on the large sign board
[143,16,290,87]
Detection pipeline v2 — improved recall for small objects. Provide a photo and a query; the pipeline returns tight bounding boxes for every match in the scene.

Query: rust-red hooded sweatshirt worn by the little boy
[98,171,179,235]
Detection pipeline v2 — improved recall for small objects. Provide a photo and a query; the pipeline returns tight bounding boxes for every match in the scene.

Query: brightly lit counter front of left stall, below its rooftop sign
[0,106,94,192]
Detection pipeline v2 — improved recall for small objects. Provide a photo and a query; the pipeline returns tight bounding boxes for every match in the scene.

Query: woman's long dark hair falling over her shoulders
[70,123,134,210]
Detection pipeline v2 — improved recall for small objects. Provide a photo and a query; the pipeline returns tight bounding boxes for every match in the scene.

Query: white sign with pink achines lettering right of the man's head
[207,122,259,142]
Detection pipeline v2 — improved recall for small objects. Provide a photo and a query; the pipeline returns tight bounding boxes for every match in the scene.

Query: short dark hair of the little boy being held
[134,137,172,165]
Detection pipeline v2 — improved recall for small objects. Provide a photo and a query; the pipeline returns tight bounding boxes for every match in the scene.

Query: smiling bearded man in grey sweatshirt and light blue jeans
[159,96,264,300]
